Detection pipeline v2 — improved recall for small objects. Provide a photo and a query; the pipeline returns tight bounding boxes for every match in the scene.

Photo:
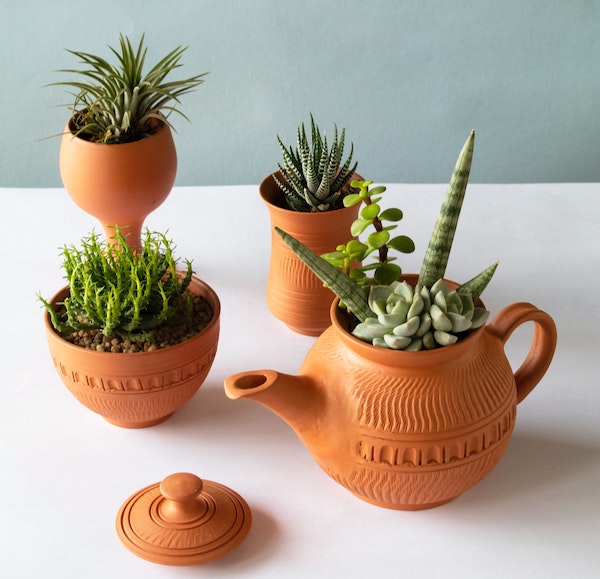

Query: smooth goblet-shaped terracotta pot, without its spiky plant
[60,122,177,247]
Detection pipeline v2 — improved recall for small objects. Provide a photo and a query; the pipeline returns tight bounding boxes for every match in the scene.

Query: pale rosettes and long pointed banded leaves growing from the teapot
[278,132,497,351]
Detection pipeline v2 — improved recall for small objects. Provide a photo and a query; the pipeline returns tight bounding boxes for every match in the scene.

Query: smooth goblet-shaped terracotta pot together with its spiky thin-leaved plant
[54,34,205,247]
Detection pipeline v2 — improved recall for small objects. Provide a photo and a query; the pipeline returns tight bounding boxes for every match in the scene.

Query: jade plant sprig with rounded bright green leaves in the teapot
[321,180,415,285]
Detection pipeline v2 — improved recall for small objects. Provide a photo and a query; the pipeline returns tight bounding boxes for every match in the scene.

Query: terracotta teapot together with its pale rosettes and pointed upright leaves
[225,133,556,510]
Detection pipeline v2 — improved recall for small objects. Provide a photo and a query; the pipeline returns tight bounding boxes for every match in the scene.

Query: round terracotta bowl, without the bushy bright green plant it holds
[44,277,221,428]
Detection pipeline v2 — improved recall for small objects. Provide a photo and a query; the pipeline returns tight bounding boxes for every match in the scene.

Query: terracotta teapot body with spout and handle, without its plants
[225,278,556,510]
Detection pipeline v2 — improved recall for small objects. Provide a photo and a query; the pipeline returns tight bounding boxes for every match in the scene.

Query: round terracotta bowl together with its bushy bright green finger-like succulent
[39,227,220,428]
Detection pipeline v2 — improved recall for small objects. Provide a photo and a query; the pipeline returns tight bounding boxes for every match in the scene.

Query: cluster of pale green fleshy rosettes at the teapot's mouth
[352,279,489,352]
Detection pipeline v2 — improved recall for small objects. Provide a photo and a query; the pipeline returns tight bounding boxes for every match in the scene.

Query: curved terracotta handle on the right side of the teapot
[488,302,557,402]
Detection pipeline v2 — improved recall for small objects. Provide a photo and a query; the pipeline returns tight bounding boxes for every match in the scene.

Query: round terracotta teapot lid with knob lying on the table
[116,473,252,565]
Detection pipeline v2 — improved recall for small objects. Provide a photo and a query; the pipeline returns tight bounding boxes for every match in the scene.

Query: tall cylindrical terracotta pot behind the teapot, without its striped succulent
[259,171,361,336]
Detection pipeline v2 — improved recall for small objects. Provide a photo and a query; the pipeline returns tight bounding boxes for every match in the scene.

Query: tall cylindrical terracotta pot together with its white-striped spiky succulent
[259,115,357,336]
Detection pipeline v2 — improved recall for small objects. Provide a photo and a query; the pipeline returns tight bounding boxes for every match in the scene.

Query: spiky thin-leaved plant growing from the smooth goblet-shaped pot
[53,34,206,144]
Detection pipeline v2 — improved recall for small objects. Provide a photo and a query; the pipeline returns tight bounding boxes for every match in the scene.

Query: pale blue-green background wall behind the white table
[0,0,600,187]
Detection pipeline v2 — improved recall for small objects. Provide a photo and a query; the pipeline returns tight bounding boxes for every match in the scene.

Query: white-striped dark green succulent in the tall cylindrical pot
[275,115,357,212]
